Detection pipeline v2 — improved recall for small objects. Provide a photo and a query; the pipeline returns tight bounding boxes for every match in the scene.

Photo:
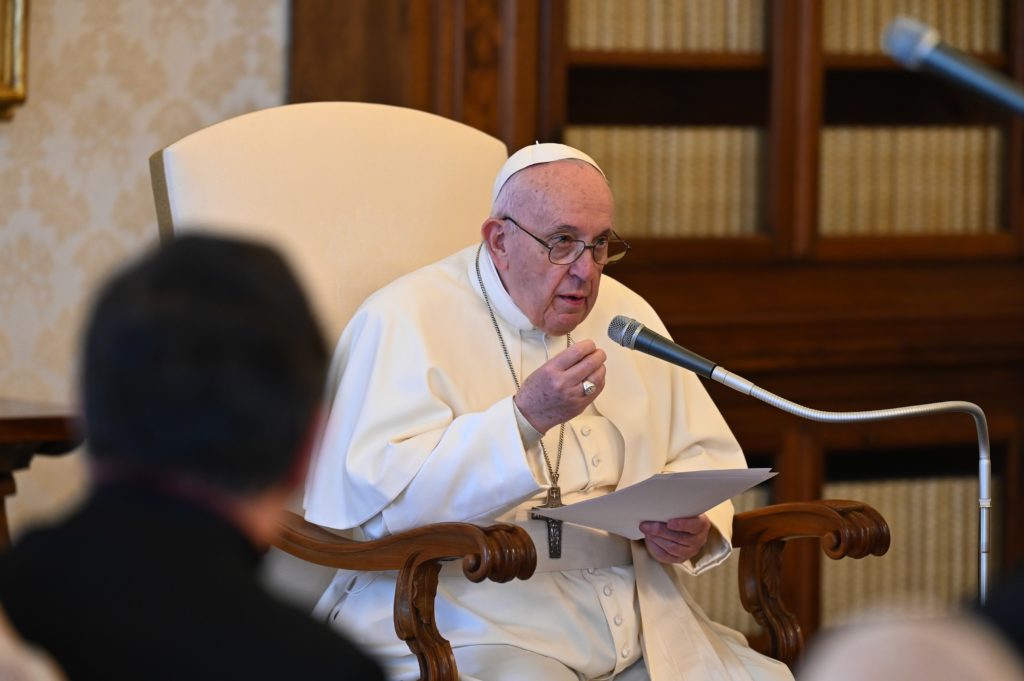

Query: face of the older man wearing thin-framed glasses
[493,161,614,336]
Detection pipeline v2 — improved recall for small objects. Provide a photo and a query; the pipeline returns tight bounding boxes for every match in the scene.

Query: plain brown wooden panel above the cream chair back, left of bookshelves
[289,0,541,148]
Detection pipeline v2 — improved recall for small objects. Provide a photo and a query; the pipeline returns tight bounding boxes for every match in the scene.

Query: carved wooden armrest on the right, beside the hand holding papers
[732,500,889,665]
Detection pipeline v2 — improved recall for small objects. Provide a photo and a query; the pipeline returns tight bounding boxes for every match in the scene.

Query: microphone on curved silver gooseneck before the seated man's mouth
[608,314,992,603]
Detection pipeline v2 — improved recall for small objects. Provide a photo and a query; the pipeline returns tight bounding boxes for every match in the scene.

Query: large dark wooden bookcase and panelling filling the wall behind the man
[289,0,1024,651]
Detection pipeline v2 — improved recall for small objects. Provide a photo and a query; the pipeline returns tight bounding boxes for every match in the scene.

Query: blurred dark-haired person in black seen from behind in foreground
[0,236,382,680]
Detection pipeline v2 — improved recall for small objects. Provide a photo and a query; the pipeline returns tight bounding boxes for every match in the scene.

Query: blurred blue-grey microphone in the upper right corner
[882,16,1024,114]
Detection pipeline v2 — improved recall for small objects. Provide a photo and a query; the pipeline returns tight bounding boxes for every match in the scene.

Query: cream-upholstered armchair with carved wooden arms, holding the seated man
[151,102,889,680]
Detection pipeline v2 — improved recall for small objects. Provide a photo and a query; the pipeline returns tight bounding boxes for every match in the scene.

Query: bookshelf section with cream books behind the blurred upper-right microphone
[812,0,1020,258]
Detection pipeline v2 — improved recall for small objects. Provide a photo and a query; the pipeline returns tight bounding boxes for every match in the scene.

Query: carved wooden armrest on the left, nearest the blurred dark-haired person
[274,513,537,681]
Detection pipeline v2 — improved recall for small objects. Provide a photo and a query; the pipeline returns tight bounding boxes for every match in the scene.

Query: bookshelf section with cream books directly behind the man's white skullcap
[540,0,773,261]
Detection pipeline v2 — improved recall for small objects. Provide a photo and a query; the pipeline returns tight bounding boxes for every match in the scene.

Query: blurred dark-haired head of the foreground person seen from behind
[80,236,328,540]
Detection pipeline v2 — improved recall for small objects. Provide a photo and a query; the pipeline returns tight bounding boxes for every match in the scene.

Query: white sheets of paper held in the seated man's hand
[535,468,776,539]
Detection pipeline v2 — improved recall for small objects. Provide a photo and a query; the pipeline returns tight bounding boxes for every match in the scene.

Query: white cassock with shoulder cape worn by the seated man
[304,246,792,681]
